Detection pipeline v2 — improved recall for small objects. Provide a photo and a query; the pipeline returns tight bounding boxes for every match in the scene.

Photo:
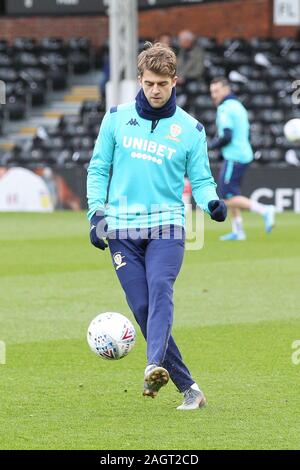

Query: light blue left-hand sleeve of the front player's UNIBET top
[87,112,115,219]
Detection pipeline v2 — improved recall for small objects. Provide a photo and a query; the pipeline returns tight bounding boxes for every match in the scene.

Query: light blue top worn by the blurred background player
[217,95,253,163]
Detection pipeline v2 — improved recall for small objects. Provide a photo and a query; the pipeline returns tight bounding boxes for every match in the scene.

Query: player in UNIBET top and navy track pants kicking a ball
[87,43,226,410]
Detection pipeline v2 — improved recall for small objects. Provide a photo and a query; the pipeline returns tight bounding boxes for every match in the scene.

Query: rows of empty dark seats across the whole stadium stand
[0,37,300,167]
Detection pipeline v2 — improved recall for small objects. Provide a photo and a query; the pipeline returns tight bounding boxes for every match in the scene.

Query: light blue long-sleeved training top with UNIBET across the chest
[87,102,219,230]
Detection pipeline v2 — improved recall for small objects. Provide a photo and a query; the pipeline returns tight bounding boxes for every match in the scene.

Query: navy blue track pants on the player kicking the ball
[108,226,194,392]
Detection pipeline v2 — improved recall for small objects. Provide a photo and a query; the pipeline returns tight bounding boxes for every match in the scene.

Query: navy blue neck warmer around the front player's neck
[135,87,176,121]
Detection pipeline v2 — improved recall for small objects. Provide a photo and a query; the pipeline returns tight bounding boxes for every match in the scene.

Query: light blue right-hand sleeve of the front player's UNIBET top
[187,124,219,213]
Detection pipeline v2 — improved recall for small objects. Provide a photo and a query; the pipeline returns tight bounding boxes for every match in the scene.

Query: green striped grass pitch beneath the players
[0,213,300,450]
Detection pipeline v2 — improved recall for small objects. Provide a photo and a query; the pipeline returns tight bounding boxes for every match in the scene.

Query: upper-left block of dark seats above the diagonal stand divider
[0,38,94,120]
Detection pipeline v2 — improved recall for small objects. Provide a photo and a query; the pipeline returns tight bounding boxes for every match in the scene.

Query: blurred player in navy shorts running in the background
[208,77,275,240]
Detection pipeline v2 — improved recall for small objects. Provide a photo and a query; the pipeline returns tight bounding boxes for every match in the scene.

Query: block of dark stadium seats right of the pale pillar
[184,38,300,163]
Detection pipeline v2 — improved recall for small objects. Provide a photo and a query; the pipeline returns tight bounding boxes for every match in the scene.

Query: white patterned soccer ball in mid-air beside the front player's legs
[87,312,136,359]
